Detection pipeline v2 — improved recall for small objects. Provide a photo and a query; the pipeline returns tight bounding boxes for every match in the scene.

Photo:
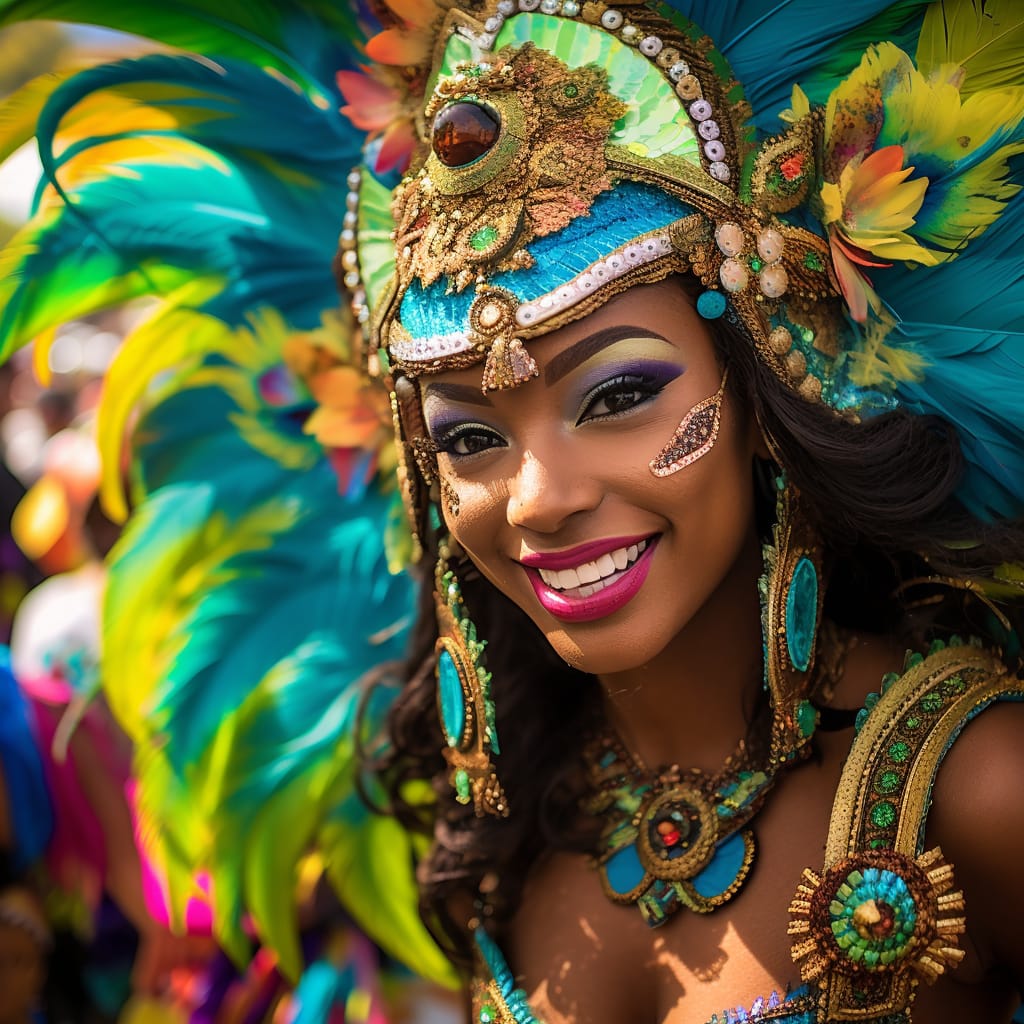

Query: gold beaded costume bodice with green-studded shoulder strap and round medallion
[472,640,1024,1024]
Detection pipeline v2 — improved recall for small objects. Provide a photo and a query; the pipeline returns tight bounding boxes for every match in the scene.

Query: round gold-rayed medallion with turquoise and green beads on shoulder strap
[788,847,966,1021]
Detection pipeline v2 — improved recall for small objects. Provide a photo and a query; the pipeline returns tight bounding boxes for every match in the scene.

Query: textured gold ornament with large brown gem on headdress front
[393,43,627,291]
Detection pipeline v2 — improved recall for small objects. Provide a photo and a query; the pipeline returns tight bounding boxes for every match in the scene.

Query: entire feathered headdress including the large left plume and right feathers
[0,0,1024,1003]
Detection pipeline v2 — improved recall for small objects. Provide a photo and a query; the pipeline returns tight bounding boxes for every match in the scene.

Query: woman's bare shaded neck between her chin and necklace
[600,532,763,771]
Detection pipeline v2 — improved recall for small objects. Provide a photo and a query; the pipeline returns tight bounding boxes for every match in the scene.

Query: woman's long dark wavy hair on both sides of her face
[372,285,1024,968]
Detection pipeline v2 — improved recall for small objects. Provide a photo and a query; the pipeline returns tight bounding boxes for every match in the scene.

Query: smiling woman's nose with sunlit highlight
[506,450,603,534]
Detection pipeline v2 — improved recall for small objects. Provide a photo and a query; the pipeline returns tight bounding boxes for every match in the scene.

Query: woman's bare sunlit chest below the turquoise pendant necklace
[506,763,838,1024]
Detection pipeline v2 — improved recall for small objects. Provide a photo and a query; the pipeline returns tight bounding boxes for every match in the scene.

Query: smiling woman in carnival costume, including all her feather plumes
[0,0,1024,1024]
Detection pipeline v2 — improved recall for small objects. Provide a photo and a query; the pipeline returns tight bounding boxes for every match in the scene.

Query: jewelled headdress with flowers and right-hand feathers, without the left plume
[344,0,1024,518]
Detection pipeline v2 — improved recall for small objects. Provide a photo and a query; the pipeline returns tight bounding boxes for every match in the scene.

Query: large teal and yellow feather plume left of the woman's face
[0,0,453,982]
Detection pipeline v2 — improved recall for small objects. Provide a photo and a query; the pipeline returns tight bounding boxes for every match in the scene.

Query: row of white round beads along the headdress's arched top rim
[458,0,732,183]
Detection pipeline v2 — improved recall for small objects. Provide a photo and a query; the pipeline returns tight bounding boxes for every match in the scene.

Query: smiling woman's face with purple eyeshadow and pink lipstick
[422,282,757,674]
